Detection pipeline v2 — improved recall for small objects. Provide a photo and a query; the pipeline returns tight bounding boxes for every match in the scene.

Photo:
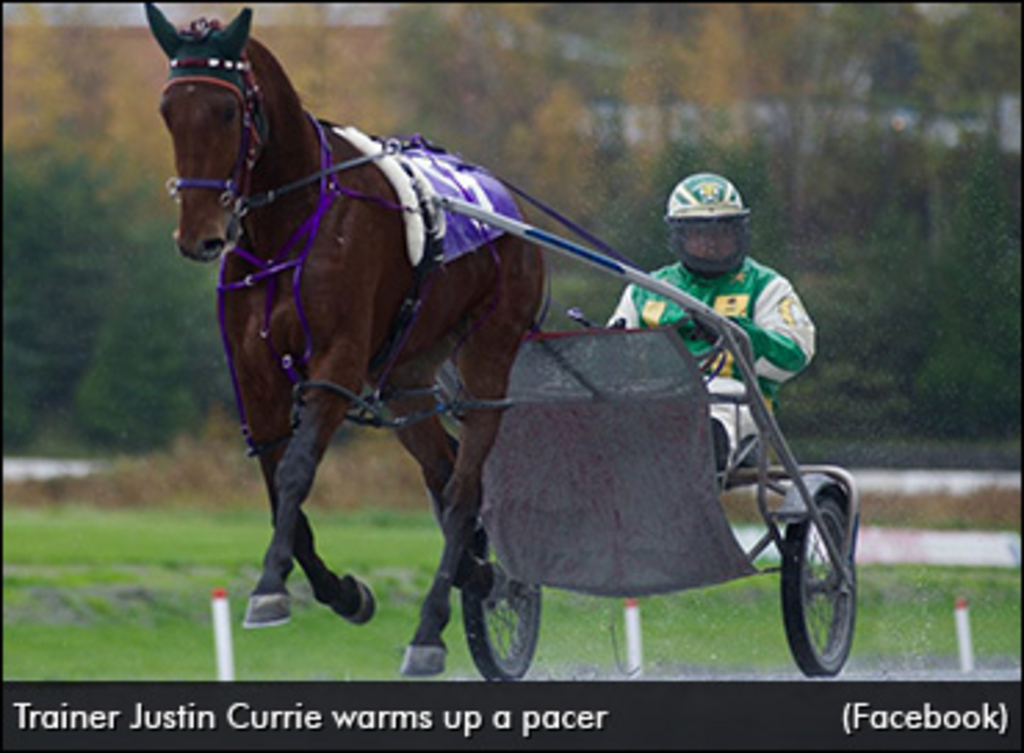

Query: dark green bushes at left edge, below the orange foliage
[4,147,223,450]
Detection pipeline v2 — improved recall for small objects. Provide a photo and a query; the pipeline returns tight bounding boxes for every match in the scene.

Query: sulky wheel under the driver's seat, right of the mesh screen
[781,490,857,677]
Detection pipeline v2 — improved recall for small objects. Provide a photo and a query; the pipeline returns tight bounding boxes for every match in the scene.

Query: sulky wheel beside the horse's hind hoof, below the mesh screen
[462,529,541,680]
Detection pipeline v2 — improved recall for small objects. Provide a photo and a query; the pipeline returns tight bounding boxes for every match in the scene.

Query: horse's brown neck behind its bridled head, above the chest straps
[244,40,321,258]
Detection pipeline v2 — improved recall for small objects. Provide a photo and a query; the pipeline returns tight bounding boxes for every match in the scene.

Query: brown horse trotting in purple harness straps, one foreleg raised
[145,4,545,676]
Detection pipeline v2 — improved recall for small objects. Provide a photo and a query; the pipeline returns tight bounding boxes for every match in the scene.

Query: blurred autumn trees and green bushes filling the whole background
[3,3,1021,449]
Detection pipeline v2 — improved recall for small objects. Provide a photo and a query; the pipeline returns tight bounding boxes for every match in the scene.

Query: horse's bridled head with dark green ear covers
[145,3,265,261]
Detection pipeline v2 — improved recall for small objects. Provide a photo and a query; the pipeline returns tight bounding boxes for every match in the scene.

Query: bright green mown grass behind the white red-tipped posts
[3,504,1021,680]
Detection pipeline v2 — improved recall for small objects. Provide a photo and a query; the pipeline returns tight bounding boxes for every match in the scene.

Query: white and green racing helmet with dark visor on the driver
[665,172,751,277]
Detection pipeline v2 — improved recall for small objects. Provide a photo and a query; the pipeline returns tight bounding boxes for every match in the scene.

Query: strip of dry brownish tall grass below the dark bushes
[4,417,1021,533]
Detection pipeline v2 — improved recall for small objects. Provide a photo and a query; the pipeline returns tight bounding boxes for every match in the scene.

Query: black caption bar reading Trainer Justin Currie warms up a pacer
[3,680,1021,750]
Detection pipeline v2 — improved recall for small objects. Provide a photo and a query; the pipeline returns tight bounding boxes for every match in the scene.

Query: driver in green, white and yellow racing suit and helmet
[608,172,815,472]
